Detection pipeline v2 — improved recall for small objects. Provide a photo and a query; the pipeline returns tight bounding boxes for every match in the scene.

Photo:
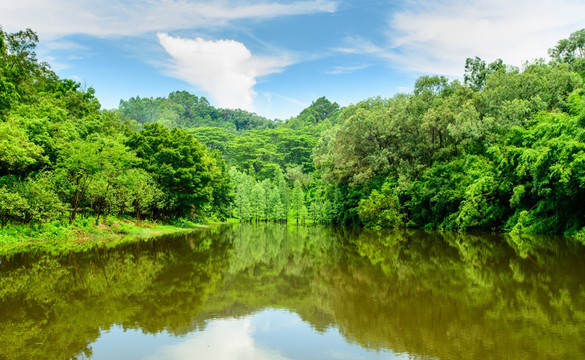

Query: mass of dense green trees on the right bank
[311,31,585,234]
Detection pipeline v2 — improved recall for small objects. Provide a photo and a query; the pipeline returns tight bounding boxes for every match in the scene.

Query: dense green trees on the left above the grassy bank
[0,30,232,226]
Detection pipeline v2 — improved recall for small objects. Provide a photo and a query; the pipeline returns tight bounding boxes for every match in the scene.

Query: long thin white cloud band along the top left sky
[0,0,337,40]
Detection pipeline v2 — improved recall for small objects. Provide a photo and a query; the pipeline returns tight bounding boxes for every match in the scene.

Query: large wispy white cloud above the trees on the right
[337,0,585,76]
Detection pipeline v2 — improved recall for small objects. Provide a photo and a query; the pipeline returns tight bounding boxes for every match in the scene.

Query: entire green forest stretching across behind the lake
[0,28,585,236]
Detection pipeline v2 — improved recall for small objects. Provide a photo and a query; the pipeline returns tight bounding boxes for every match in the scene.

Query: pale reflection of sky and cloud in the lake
[92,309,408,360]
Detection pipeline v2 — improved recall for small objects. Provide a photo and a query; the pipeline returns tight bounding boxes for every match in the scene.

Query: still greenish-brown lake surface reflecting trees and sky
[0,224,585,360]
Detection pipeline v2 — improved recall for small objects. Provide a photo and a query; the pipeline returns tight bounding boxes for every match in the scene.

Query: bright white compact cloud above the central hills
[158,33,293,111]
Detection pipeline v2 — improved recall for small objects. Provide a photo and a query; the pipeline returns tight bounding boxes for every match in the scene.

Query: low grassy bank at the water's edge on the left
[0,217,205,256]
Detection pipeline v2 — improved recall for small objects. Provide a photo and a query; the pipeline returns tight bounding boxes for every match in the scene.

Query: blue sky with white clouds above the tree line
[0,0,585,119]
